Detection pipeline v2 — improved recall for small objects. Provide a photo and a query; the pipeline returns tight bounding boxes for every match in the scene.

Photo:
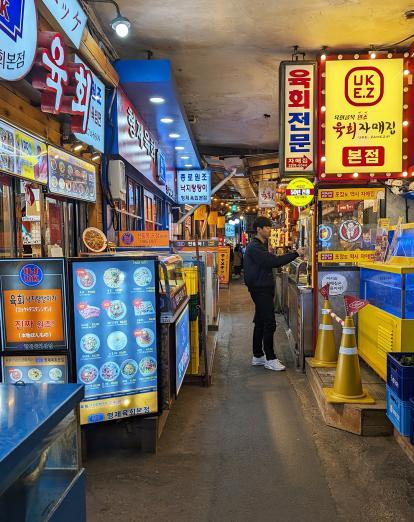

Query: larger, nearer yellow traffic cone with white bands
[323,315,375,404]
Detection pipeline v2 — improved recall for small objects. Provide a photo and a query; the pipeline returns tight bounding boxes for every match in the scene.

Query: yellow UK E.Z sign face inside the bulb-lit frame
[324,58,403,174]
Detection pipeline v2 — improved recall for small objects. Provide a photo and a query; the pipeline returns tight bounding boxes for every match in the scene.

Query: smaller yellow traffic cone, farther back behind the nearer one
[308,299,338,368]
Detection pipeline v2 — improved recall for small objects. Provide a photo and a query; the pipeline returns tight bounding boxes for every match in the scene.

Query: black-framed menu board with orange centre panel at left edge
[0,258,70,384]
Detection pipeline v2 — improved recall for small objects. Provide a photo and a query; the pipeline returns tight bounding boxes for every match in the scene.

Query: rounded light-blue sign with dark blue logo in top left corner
[0,0,37,81]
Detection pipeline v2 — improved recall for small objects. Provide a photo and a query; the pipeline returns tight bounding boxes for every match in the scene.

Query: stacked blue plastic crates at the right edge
[387,352,414,436]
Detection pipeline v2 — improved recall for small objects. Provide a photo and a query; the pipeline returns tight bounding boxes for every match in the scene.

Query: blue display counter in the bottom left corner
[0,384,86,522]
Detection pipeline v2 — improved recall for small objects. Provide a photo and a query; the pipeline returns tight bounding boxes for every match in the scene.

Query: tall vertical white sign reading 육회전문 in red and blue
[279,61,316,177]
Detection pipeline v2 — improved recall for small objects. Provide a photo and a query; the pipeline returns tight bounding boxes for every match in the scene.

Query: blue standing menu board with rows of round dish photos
[72,258,158,424]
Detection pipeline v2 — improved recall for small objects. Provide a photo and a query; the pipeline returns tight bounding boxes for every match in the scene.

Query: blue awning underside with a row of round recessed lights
[114,60,202,170]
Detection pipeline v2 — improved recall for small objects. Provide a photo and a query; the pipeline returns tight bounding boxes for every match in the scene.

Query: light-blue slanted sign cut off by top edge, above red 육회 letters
[41,0,88,49]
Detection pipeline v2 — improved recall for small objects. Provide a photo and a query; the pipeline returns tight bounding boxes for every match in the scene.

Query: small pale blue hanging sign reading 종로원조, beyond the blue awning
[177,170,211,205]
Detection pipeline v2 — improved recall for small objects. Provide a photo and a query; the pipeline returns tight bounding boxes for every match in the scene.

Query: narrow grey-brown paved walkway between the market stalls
[87,284,414,522]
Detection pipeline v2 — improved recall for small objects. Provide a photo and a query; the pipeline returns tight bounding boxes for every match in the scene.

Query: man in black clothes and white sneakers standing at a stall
[244,216,303,371]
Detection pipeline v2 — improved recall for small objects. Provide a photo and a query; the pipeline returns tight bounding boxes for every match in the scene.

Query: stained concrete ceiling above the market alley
[91,0,414,152]
